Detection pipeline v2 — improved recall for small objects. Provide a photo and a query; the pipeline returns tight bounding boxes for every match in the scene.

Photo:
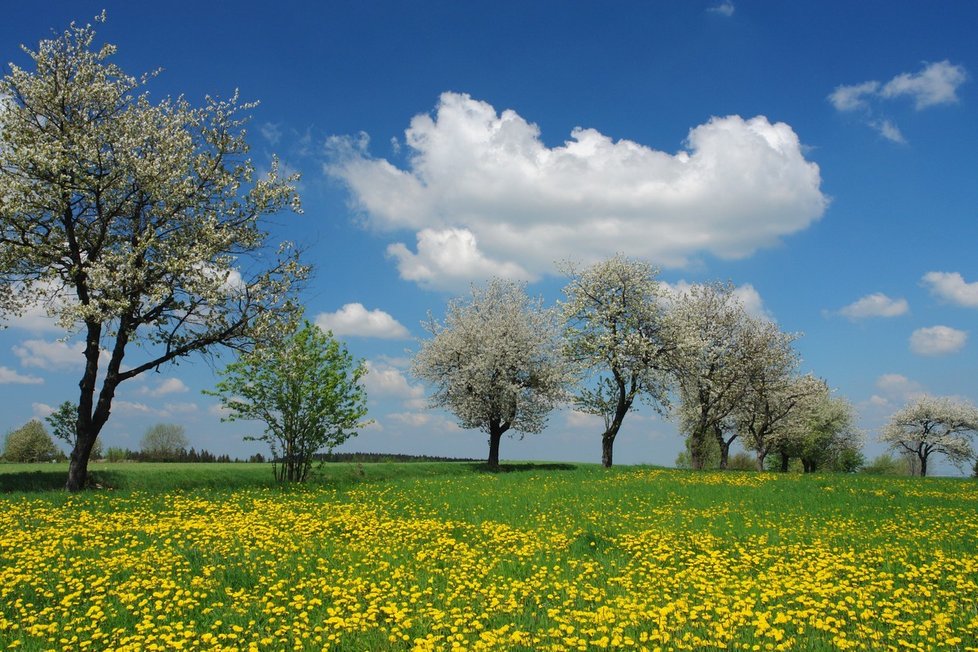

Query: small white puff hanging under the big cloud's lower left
[387,229,536,290]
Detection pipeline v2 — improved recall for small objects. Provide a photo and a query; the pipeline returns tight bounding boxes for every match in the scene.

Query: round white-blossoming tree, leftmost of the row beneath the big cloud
[413,279,571,469]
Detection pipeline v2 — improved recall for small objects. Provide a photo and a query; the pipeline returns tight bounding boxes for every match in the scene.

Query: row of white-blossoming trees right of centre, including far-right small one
[413,256,978,475]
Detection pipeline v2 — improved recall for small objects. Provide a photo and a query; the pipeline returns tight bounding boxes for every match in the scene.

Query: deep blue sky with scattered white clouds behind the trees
[0,0,978,473]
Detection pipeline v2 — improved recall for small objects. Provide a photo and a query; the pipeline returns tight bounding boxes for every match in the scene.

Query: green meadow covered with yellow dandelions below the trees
[0,464,978,650]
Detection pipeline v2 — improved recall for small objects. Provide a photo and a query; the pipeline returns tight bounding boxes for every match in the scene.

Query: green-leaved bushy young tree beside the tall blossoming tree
[204,321,367,482]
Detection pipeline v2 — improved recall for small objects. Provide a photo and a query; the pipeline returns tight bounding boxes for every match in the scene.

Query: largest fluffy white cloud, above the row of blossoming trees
[326,93,828,287]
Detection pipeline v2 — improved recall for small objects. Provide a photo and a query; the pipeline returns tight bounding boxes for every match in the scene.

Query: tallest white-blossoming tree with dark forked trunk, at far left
[0,15,307,490]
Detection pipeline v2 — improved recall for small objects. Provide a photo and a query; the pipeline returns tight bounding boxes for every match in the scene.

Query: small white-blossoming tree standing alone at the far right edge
[880,396,978,476]
